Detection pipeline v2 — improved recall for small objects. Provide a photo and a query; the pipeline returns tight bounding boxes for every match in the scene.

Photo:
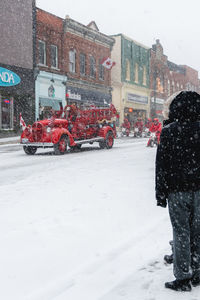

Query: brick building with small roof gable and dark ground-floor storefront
[63,16,114,106]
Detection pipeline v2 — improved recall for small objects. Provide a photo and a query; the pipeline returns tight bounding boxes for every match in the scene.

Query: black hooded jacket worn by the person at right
[156,91,200,207]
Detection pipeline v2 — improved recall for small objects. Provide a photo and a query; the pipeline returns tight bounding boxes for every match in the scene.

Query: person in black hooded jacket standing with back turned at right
[156,91,200,291]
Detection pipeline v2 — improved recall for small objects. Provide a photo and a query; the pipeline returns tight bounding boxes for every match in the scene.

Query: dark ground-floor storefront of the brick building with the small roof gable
[66,85,112,106]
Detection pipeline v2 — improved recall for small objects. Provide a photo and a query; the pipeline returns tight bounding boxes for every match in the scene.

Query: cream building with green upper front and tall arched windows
[111,34,150,125]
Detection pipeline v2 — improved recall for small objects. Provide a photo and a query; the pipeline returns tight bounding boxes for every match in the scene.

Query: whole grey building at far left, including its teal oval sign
[0,0,35,136]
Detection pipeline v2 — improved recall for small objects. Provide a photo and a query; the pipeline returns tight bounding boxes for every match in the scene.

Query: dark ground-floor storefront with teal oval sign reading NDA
[0,64,34,136]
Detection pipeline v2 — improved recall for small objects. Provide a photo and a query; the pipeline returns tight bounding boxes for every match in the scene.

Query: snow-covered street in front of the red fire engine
[0,138,200,300]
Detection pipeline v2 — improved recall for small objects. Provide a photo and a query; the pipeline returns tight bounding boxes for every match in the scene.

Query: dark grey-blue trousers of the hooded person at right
[168,190,200,280]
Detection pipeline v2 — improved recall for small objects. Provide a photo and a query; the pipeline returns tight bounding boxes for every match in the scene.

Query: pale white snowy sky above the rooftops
[36,0,200,77]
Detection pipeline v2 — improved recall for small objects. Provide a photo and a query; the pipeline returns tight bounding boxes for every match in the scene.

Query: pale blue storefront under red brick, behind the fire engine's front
[35,71,67,120]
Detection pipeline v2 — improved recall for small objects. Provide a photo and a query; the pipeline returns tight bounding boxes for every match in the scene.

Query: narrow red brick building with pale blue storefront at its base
[35,8,67,119]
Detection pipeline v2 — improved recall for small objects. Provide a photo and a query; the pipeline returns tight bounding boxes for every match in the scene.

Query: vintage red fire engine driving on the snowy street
[20,104,119,155]
